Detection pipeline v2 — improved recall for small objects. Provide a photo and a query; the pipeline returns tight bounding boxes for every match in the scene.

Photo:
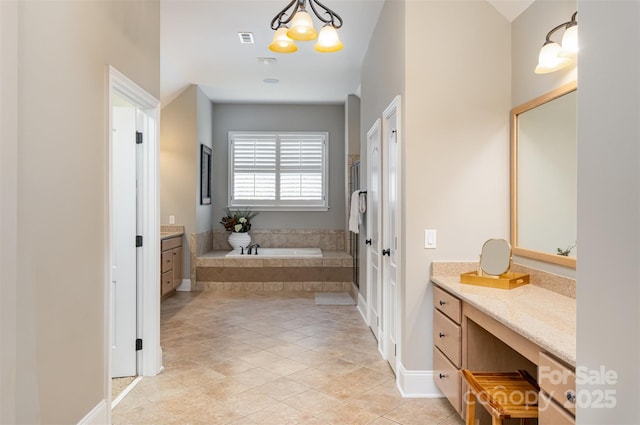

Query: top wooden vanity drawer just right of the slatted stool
[538,353,576,415]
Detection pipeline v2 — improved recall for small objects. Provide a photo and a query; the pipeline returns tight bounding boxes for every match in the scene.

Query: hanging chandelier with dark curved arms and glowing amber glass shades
[269,0,343,53]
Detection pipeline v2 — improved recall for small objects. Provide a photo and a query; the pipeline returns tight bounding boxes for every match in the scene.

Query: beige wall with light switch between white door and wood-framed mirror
[402,1,511,370]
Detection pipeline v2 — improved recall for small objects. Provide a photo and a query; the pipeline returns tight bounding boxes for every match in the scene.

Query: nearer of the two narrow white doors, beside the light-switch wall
[381,97,400,372]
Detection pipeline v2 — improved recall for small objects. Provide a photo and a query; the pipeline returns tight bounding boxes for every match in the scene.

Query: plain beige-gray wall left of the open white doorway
[0,1,160,424]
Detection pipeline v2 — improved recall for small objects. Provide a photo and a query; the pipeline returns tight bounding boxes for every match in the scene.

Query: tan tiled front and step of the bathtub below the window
[195,250,353,292]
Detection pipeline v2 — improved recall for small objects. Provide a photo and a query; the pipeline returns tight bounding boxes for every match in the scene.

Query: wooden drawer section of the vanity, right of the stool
[538,352,576,425]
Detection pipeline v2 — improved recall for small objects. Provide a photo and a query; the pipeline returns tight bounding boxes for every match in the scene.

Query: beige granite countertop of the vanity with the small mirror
[431,276,576,366]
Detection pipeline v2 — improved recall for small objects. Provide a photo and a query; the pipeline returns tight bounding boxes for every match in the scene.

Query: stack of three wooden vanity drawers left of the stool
[433,286,462,414]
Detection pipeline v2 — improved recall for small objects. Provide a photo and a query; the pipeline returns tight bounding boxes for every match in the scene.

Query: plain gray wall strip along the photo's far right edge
[577,0,640,425]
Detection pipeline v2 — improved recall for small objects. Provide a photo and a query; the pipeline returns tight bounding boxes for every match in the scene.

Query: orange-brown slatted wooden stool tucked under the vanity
[460,369,540,425]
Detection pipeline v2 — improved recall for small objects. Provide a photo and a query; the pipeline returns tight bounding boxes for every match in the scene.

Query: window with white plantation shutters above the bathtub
[229,131,329,210]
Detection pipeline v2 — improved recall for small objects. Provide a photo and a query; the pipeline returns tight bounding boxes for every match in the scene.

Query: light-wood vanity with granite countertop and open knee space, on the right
[431,276,576,425]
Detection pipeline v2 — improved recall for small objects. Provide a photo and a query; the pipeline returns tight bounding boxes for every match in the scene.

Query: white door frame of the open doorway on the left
[104,65,162,400]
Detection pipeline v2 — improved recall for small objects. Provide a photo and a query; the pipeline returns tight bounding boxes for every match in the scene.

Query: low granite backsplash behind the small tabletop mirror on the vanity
[431,261,576,298]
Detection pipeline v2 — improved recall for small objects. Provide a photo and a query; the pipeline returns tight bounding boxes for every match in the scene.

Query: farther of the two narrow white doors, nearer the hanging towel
[365,119,382,342]
